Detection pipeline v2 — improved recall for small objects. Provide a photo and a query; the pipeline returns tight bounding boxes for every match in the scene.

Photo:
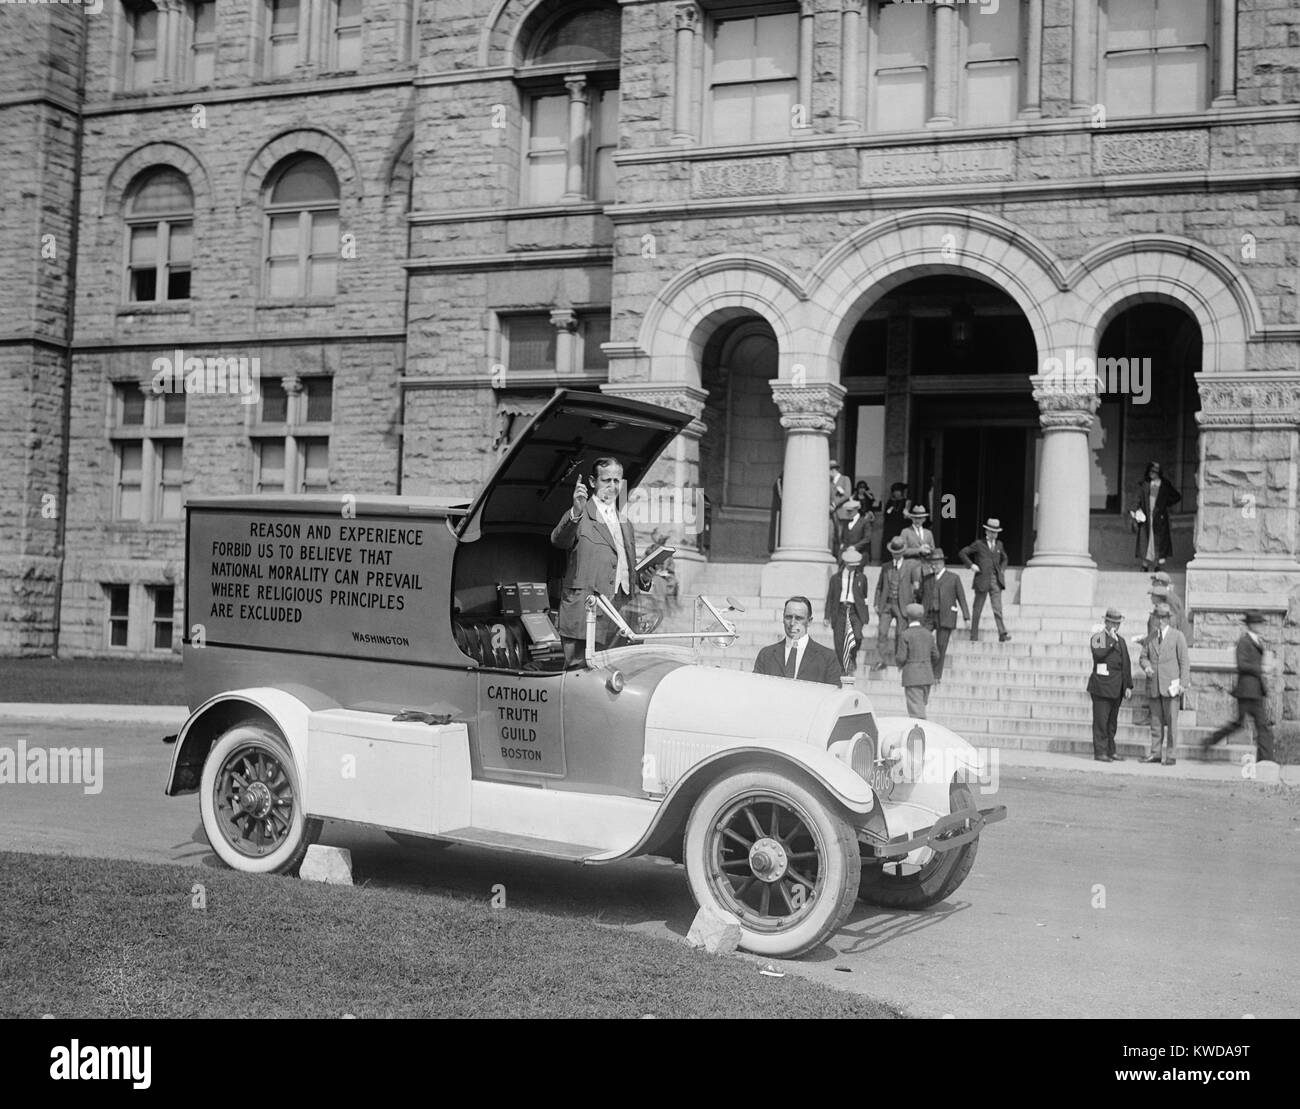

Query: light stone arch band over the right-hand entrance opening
[1070,235,1262,373]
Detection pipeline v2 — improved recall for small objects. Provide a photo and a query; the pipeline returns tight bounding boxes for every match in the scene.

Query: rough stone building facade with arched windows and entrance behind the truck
[0,0,1300,715]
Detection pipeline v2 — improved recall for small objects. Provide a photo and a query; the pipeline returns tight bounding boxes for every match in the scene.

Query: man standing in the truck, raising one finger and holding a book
[551,458,647,664]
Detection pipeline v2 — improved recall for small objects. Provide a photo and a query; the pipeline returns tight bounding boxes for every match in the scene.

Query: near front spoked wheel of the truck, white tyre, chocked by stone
[685,771,862,957]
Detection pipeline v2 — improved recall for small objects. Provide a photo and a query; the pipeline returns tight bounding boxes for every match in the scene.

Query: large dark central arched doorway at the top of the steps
[832,274,1039,564]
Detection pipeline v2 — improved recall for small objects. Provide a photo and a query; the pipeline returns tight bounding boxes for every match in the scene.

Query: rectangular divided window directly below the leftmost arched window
[112,381,186,523]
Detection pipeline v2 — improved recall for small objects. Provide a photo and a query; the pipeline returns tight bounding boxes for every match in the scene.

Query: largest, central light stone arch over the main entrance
[807,208,1066,366]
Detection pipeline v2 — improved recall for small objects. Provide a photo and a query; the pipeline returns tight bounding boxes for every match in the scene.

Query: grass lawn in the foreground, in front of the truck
[0,852,900,1018]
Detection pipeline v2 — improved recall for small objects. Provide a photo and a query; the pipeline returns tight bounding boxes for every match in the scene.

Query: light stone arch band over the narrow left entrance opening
[638,254,806,387]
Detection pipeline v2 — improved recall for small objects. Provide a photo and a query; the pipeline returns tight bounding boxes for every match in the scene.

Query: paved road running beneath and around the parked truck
[0,723,1300,1018]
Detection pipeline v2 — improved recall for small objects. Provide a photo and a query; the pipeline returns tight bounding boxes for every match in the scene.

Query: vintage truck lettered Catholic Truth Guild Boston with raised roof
[166,391,1005,956]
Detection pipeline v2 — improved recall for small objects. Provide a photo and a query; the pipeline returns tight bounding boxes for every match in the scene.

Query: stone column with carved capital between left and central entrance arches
[761,380,846,598]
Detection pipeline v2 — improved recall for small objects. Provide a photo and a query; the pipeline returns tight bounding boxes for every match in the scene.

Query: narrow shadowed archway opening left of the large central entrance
[699,313,785,562]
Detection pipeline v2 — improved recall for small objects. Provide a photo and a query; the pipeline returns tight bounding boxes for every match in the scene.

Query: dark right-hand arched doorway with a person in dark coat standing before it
[1089,302,1201,569]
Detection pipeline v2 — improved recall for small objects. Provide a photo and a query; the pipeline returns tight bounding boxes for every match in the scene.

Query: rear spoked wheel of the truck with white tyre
[199,724,321,874]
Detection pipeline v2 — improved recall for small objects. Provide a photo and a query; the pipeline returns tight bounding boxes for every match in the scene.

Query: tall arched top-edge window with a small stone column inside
[519,5,621,204]
